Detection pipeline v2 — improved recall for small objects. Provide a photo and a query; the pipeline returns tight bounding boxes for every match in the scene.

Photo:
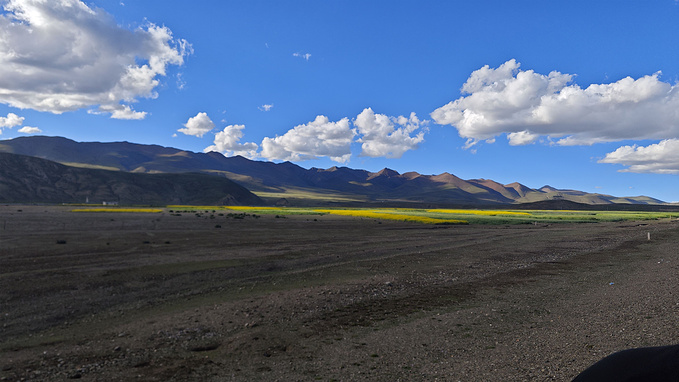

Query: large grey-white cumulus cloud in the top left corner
[0,0,192,119]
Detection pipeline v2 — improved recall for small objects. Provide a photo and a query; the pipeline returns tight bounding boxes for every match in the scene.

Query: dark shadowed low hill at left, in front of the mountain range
[0,153,264,205]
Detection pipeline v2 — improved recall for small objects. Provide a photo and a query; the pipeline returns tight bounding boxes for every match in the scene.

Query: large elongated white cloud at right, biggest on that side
[431,60,679,147]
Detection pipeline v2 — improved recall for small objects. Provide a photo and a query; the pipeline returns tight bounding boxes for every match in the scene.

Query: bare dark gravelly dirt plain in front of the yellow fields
[0,206,679,381]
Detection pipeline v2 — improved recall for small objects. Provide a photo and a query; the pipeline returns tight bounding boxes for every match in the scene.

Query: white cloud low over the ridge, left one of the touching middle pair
[260,115,356,163]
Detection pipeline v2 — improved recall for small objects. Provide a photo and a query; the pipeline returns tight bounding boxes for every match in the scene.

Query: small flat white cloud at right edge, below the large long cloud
[599,139,679,174]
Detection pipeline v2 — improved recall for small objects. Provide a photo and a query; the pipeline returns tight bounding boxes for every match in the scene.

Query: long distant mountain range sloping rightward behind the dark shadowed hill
[0,136,664,206]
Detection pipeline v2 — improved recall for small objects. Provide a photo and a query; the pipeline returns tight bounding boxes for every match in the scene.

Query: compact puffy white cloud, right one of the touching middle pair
[354,108,427,158]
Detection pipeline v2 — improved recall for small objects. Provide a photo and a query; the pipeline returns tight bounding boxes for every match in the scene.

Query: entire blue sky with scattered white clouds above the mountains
[0,0,679,201]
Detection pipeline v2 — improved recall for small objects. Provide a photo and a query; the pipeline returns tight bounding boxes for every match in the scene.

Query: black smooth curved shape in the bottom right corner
[573,345,679,382]
